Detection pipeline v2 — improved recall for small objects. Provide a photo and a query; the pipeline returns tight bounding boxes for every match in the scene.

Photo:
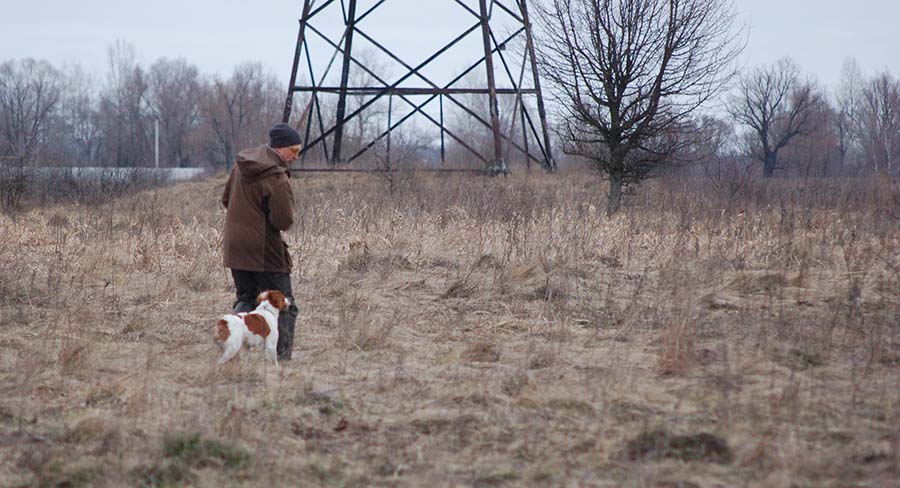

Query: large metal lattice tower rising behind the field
[283,0,556,171]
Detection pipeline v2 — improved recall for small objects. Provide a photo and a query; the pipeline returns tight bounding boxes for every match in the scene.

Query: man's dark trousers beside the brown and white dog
[231,269,299,359]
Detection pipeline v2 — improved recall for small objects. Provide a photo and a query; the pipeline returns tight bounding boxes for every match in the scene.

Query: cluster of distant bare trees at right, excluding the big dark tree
[729,59,900,176]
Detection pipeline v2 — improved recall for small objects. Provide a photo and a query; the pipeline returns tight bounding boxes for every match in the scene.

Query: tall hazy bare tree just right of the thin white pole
[148,58,200,166]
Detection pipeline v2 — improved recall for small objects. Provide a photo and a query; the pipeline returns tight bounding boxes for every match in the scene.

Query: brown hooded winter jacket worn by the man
[222,145,294,273]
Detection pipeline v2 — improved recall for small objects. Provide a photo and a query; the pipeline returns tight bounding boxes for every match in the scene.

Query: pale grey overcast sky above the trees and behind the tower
[0,0,900,90]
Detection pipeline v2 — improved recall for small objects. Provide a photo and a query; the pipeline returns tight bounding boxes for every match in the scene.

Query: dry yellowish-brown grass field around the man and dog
[0,173,900,488]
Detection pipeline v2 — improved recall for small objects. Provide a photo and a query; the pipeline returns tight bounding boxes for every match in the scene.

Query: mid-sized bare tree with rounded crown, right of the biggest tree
[730,58,819,177]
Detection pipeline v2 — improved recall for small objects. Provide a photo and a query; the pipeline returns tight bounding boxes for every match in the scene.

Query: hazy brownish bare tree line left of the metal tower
[0,41,286,172]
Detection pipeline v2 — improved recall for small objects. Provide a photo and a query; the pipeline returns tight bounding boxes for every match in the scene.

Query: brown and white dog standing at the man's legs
[213,290,291,366]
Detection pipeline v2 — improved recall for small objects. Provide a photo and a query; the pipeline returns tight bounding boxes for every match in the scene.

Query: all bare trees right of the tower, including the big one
[538,0,900,213]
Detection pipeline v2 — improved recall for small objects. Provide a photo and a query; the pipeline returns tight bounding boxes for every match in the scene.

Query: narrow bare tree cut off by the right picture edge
[860,72,900,173]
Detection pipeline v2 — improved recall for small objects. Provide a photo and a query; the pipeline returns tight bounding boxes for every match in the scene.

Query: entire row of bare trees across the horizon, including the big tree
[0,10,900,199]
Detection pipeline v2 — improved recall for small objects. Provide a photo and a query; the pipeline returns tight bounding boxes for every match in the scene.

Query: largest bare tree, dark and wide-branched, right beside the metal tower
[538,0,742,214]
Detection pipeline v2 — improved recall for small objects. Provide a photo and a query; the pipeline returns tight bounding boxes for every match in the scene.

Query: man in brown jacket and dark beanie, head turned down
[222,124,302,360]
